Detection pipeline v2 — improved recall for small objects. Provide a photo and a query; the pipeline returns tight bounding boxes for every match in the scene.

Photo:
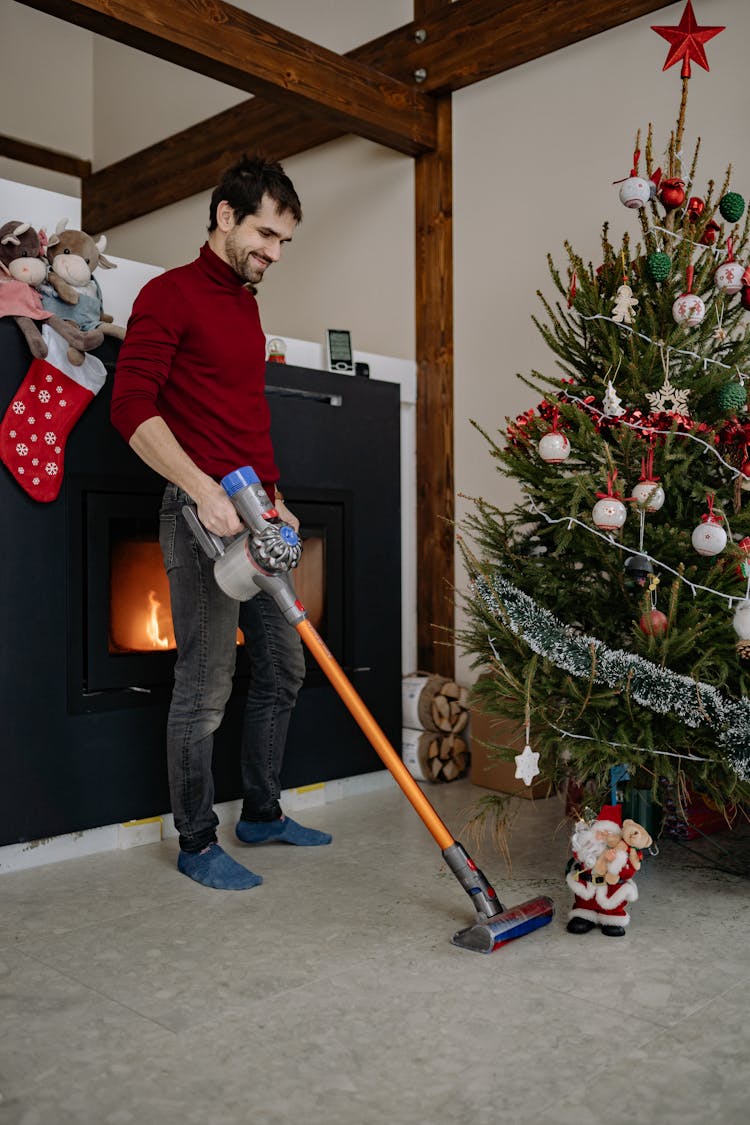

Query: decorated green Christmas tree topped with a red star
[461,2,750,818]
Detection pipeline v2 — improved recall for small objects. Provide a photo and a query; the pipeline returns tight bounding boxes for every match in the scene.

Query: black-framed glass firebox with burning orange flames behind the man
[69,477,351,712]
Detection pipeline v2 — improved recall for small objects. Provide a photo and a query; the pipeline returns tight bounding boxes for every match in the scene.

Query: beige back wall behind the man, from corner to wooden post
[94,0,414,358]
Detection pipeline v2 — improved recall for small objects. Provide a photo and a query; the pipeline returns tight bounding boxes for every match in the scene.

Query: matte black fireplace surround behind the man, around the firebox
[0,318,401,845]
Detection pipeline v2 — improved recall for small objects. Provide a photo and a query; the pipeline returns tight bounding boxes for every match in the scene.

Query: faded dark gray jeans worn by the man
[160,485,305,852]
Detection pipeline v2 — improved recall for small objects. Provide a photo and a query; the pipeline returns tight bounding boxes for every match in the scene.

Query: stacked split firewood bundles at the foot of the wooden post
[401,674,469,782]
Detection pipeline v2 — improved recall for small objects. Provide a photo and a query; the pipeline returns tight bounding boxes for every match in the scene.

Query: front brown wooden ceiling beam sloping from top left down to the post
[20,0,436,156]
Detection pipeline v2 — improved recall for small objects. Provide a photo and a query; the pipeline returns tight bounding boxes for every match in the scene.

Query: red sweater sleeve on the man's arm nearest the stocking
[111,273,184,441]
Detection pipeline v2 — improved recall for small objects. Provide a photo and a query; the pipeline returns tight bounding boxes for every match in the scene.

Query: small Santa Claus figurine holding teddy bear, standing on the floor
[566,804,652,937]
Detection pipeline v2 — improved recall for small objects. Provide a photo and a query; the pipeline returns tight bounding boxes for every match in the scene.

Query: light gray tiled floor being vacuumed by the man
[0,782,750,1125]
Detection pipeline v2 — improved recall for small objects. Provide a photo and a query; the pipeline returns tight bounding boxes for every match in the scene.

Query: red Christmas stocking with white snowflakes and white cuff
[0,326,107,504]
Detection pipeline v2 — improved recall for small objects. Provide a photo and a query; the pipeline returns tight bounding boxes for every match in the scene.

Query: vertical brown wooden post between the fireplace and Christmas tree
[414,0,455,677]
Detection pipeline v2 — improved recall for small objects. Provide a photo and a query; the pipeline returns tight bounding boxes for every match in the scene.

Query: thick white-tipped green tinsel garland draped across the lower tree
[473,570,750,781]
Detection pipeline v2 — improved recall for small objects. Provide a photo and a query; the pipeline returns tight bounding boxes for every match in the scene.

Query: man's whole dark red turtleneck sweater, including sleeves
[111,243,279,485]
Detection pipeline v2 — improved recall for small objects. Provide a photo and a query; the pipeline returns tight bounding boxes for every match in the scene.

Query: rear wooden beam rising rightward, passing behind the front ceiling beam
[79,0,668,232]
